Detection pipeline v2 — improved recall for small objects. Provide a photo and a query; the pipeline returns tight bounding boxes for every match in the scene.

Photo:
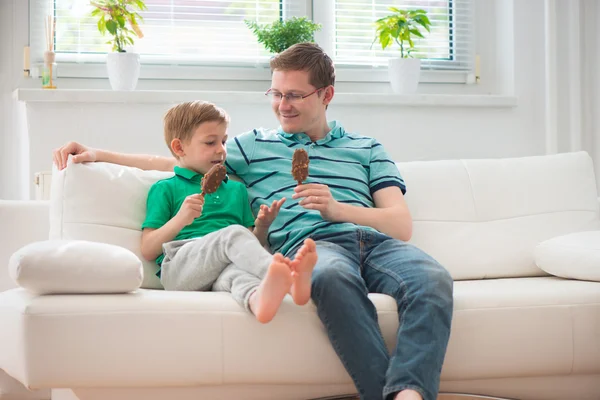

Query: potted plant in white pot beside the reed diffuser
[90,0,146,90]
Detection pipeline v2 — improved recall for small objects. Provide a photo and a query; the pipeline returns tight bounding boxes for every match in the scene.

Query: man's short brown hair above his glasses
[270,43,335,88]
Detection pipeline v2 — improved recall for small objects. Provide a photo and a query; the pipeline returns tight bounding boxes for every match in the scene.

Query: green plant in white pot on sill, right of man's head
[375,7,431,94]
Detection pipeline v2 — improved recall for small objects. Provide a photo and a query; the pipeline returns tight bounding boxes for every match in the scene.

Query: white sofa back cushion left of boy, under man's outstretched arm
[50,162,173,289]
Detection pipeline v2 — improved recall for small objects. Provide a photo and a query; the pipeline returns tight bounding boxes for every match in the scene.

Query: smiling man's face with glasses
[271,70,325,133]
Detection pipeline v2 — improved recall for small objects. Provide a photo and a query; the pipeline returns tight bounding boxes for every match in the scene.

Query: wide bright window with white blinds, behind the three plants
[30,0,474,82]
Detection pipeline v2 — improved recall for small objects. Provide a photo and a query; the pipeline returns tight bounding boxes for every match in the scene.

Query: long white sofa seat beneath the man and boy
[0,277,600,388]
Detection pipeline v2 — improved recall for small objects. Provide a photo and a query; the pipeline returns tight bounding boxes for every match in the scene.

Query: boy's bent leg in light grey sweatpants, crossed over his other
[161,225,273,290]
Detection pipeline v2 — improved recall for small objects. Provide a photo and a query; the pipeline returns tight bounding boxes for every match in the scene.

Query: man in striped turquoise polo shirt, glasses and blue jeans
[54,43,453,400]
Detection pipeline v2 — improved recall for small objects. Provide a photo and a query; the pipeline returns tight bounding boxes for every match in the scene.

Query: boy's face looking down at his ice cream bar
[179,121,227,174]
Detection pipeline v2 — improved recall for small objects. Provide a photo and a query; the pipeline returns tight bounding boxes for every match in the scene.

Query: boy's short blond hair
[164,101,229,157]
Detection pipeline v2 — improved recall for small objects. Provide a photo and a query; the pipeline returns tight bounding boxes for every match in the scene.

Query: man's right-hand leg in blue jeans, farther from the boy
[363,232,453,400]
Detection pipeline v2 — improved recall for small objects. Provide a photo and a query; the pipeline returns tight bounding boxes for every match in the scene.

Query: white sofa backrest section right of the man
[397,152,600,280]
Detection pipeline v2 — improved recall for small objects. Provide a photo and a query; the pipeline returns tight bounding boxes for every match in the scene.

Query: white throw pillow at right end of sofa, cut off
[535,231,600,282]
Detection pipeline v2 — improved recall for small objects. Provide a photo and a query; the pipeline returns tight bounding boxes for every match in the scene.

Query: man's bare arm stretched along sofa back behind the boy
[53,142,177,171]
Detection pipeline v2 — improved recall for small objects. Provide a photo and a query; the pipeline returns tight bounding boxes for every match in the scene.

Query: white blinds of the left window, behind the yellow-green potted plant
[31,0,284,64]
